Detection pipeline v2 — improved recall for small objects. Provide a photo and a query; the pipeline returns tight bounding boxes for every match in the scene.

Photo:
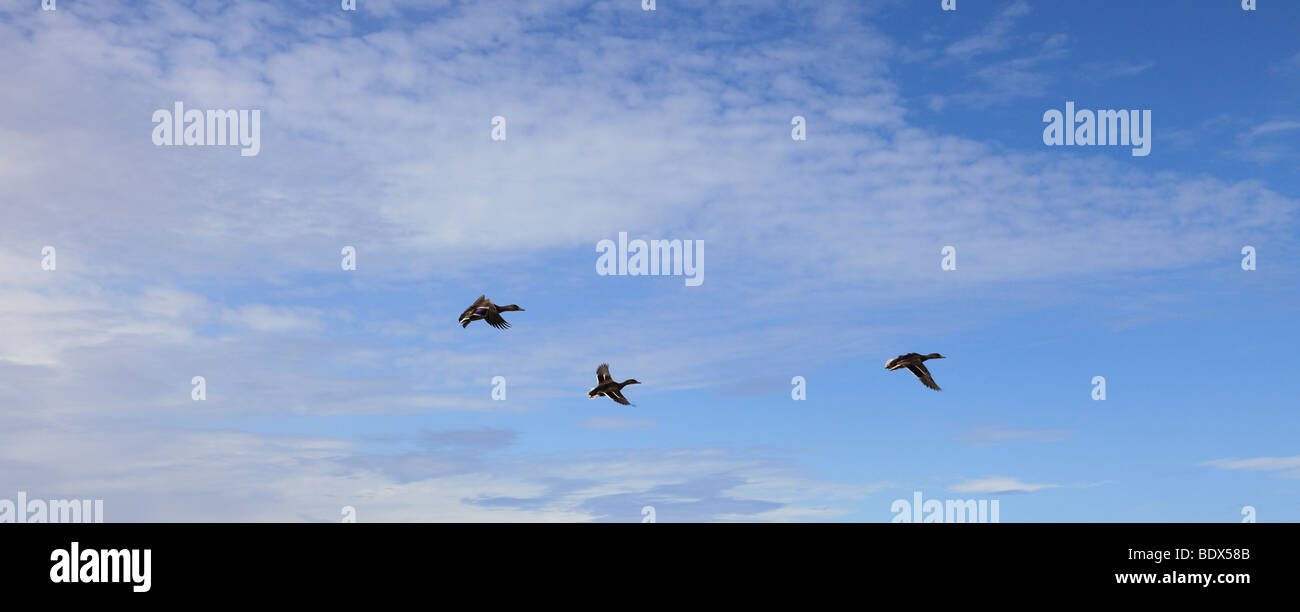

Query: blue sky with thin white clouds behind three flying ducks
[0,0,1300,522]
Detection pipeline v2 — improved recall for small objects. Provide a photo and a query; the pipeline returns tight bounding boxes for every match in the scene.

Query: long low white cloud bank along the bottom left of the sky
[0,426,870,522]
